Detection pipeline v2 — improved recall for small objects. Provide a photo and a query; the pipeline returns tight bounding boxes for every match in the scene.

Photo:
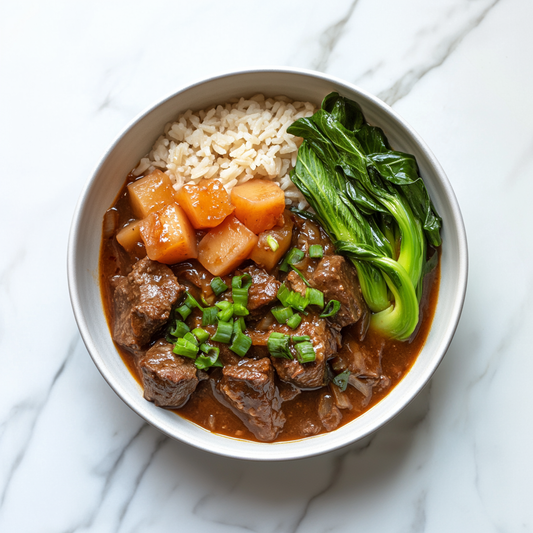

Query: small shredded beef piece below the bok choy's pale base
[331,335,383,380]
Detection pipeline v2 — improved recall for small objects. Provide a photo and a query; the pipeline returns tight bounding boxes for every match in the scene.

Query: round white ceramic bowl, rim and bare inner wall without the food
[68,68,468,460]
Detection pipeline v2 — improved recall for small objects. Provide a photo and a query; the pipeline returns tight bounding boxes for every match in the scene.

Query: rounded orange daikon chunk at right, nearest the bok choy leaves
[231,179,285,235]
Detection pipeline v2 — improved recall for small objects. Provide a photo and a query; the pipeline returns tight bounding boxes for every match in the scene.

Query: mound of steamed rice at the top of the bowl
[134,94,315,209]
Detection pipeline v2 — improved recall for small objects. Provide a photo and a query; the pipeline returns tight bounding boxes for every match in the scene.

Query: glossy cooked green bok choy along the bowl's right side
[287,93,441,340]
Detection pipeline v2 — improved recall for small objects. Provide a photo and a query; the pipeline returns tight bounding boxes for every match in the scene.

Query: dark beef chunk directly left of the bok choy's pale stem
[309,255,367,328]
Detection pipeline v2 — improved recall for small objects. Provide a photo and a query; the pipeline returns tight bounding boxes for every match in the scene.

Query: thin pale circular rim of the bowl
[67,66,468,461]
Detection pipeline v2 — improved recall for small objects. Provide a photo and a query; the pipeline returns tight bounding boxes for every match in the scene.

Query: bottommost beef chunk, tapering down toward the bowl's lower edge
[214,358,285,442]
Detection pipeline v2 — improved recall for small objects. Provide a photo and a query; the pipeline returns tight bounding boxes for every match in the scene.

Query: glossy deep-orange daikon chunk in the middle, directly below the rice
[176,179,235,229]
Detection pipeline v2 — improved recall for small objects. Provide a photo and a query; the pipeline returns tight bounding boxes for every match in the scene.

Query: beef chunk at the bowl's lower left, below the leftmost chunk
[139,339,198,409]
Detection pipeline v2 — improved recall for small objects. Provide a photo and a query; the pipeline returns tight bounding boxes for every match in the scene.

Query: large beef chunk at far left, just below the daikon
[113,257,185,350]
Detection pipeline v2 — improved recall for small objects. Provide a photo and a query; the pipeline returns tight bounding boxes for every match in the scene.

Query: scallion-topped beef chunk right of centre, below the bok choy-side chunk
[271,312,340,389]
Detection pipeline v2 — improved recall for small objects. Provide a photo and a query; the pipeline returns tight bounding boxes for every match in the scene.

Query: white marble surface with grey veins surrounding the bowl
[0,0,533,533]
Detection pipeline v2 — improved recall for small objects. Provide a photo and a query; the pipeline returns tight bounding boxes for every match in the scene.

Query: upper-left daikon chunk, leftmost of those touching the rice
[128,170,176,218]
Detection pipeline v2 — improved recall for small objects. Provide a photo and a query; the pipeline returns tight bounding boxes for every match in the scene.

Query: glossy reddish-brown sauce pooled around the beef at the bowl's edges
[99,175,440,442]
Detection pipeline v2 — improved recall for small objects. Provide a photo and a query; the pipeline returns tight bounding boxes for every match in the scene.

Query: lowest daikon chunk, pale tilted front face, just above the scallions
[198,215,257,276]
